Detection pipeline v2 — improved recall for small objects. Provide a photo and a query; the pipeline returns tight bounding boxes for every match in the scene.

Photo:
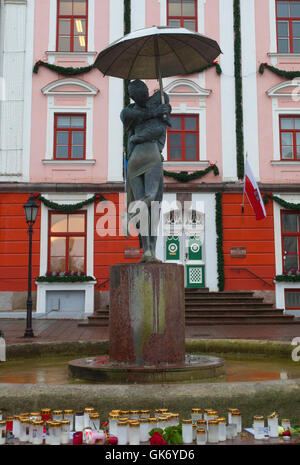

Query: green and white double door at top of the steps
[165,235,205,287]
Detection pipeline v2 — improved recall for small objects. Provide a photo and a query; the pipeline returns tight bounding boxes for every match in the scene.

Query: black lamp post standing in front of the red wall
[24,195,39,337]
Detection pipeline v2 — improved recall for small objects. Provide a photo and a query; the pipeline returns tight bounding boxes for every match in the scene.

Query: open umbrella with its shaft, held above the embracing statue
[94,26,222,103]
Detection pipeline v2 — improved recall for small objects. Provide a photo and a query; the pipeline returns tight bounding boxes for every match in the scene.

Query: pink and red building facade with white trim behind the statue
[0,0,300,315]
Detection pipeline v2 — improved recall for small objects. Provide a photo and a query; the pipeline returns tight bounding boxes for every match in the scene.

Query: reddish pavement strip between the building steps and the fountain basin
[0,319,300,344]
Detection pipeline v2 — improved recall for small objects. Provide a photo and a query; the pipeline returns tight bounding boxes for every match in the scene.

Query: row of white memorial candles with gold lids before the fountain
[0,408,290,445]
